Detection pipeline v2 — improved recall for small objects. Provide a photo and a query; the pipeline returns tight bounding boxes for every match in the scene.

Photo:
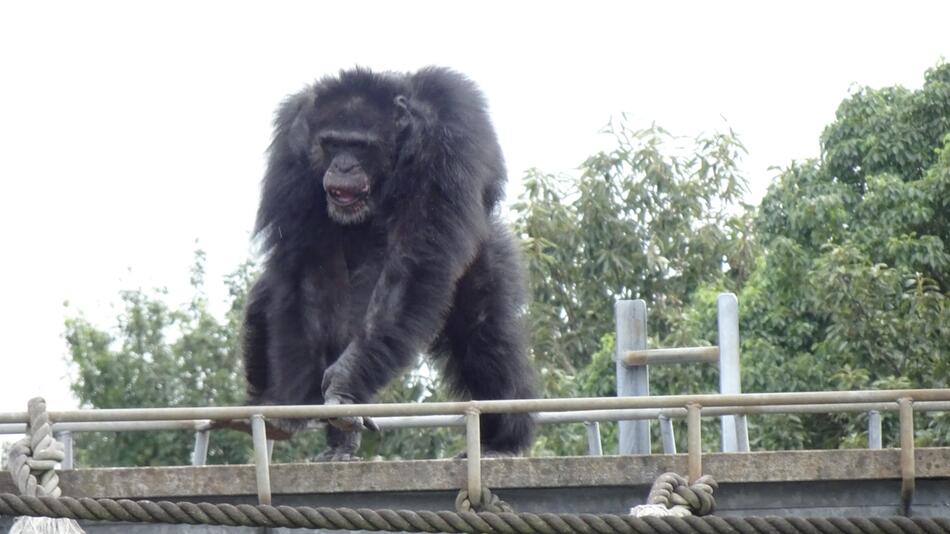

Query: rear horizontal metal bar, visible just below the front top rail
[0,401,950,434]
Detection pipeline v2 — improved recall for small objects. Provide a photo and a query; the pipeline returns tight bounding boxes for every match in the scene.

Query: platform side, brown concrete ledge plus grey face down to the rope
[0,448,950,534]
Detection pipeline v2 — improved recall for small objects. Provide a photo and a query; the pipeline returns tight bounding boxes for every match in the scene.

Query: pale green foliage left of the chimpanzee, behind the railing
[65,251,252,466]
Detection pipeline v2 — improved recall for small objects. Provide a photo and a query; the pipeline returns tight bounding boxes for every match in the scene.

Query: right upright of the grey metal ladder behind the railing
[716,293,749,452]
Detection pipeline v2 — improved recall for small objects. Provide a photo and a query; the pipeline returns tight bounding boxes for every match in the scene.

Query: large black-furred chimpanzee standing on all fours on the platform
[244,68,536,457]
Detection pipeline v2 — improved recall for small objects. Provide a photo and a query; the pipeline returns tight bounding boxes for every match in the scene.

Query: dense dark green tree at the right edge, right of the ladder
[740,64,950,448]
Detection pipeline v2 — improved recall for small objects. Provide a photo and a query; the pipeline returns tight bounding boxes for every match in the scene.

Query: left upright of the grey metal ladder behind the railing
[614,299,650,454]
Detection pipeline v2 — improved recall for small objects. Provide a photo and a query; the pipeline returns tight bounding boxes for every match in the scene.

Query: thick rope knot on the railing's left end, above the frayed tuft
[9,397,66,497]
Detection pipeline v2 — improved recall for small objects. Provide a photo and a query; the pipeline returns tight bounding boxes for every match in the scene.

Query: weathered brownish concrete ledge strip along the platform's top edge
[0,448,950,499]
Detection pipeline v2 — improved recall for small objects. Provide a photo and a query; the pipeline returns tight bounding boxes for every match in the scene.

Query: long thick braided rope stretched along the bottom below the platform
[0,493,950,534]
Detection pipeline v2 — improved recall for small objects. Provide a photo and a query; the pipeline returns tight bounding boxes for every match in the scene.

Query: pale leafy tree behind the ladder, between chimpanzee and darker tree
[514,120,755,454]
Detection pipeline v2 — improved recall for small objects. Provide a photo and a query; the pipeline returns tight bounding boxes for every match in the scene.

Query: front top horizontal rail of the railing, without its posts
[0,388,950,424]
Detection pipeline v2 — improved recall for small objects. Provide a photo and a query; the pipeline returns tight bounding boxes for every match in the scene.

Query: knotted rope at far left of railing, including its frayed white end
[7,397,83,534]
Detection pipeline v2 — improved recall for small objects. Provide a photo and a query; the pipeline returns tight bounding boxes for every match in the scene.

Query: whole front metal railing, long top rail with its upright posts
[0,389,950,506]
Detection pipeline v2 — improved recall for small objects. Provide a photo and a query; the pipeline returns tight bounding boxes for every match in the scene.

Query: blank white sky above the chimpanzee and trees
[0,0,950,432]
